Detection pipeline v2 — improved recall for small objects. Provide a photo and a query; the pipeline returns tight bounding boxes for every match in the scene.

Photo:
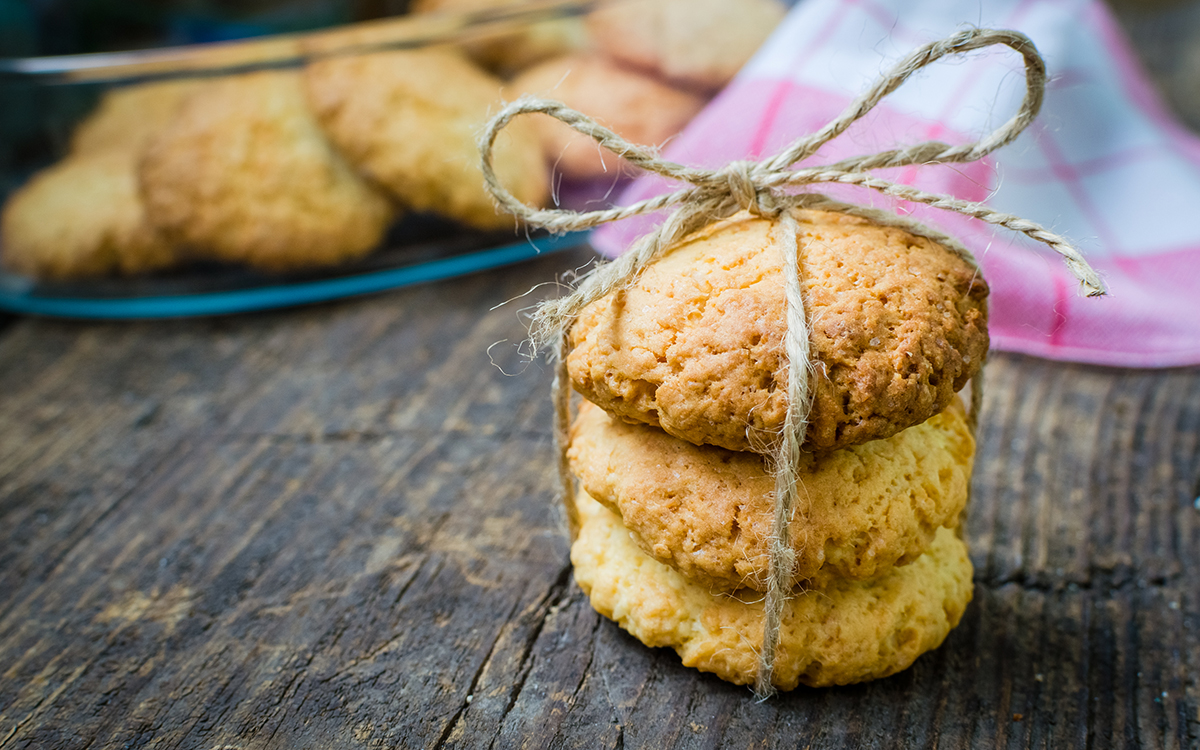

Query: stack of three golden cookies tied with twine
[568,210,988,690]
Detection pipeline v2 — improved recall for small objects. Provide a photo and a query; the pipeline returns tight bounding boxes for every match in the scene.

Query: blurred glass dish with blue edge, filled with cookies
[0,0,782,318]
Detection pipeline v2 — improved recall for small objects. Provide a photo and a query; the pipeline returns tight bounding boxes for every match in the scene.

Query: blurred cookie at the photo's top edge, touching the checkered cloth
[588,0,785,91]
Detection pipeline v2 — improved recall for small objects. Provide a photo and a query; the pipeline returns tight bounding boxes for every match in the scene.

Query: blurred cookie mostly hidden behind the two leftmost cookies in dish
[71,79,203,155]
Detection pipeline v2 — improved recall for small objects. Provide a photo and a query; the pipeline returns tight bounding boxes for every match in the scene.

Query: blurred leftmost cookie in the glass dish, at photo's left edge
[0,149,175,278]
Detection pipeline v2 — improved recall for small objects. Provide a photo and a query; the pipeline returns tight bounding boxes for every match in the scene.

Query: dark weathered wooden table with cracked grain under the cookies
[0,251,1200,749]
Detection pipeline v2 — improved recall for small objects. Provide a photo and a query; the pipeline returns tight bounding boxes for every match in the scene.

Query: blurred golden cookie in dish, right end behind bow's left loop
[305,48,550,228]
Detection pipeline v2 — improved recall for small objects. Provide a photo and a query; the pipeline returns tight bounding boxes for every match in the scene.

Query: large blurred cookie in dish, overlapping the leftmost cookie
[139,71,395,271]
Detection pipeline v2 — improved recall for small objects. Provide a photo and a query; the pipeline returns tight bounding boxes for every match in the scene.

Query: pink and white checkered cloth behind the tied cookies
[594,0,1200,367]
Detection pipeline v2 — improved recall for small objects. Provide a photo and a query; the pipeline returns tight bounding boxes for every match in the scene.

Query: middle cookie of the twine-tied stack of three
[568,400,974,590]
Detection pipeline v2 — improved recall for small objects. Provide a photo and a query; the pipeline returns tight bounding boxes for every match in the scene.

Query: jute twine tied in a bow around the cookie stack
[479,29,1104,697]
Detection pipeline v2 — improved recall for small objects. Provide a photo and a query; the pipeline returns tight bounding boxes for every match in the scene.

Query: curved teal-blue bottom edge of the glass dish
[0,232,587,320]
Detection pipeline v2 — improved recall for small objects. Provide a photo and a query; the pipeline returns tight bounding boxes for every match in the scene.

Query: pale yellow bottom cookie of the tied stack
[571,493,972,690]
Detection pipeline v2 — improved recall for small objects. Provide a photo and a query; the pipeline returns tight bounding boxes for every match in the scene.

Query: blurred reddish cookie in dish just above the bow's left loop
[510,54,704,179]
